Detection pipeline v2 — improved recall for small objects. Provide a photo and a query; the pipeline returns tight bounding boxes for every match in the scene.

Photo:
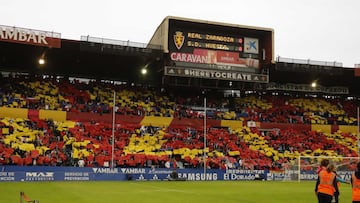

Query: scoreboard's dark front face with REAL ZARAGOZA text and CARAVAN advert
[168,19,272,73]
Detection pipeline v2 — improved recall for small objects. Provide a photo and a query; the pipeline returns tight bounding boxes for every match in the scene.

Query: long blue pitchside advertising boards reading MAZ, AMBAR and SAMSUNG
[0,166,267,182]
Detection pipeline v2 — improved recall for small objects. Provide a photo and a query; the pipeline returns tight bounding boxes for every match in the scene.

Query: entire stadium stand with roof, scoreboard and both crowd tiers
[0,18,359,174]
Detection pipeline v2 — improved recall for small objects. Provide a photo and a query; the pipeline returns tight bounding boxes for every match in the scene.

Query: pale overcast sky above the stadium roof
[0,0,360,67]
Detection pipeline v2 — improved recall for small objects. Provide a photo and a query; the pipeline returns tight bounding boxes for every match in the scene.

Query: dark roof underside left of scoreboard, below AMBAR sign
[0,39,162,83]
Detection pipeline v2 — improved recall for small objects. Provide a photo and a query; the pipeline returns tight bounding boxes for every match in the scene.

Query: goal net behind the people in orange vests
[283,156,360,181]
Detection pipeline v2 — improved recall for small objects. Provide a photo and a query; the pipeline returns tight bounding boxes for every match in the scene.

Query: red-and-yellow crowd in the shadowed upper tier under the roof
[0,71,357,125]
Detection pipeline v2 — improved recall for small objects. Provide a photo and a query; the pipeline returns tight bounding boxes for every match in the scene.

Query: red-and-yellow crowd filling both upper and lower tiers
[0,74,357,169]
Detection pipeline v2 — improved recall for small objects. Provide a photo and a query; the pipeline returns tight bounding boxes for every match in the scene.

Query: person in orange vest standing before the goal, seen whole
[315,164,339,203]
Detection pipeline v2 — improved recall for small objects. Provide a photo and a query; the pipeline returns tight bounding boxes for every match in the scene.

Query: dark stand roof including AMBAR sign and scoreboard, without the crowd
[0,16,360,95]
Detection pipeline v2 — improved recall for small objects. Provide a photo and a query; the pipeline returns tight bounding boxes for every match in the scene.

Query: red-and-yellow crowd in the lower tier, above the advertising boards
[0,118,357,170]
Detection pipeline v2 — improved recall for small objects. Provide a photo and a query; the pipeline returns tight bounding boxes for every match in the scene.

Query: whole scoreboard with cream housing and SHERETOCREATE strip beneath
[150,16,274,83]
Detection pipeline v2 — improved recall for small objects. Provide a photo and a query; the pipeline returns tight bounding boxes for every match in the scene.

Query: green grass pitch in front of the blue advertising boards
[0,181,351,203]
